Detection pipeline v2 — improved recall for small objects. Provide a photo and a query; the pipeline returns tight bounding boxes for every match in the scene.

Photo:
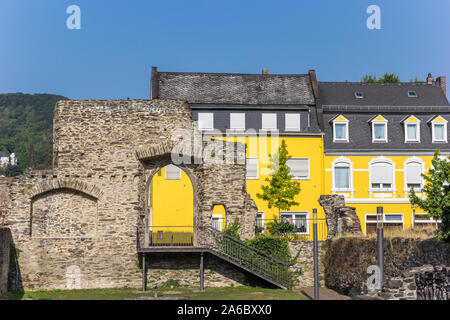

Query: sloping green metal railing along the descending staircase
[200,227,291,288]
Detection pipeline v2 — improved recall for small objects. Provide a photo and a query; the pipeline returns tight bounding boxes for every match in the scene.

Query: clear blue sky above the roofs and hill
[0,0,450,99]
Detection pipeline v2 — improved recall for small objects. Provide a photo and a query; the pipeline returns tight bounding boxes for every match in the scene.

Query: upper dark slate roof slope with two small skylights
[319,82,449,106]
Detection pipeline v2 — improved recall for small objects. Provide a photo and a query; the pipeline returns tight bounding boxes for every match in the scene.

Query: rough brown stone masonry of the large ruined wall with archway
[0,100,257,289]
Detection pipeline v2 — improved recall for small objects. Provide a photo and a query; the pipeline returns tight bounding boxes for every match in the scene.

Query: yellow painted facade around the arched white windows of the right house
[325,155,433,233]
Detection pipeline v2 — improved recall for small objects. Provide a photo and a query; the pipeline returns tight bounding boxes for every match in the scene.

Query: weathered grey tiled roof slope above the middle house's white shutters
[157,72,315,105]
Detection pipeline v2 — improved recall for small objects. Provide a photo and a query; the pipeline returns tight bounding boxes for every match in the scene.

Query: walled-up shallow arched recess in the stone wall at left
[30,188,98,239]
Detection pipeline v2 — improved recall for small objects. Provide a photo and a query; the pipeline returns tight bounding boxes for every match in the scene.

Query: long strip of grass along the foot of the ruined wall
[0,286,307,300]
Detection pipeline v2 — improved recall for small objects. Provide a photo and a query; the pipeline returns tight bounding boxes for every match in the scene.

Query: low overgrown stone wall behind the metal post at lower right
[324,237,450,295]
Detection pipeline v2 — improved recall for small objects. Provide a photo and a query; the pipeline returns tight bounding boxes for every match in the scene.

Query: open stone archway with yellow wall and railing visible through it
[145,163,197,246]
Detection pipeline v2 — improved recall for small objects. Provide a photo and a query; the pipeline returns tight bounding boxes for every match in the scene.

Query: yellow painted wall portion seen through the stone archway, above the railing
[149,167,194,231]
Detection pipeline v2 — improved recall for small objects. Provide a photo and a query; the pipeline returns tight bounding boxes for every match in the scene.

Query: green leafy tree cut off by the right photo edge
[409,149,450,242]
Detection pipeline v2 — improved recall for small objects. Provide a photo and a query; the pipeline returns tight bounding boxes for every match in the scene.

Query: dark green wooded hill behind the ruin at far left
[0,93,68,170]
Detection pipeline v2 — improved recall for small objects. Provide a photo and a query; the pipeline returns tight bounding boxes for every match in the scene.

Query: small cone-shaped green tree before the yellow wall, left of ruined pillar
[256,139,300,218]
